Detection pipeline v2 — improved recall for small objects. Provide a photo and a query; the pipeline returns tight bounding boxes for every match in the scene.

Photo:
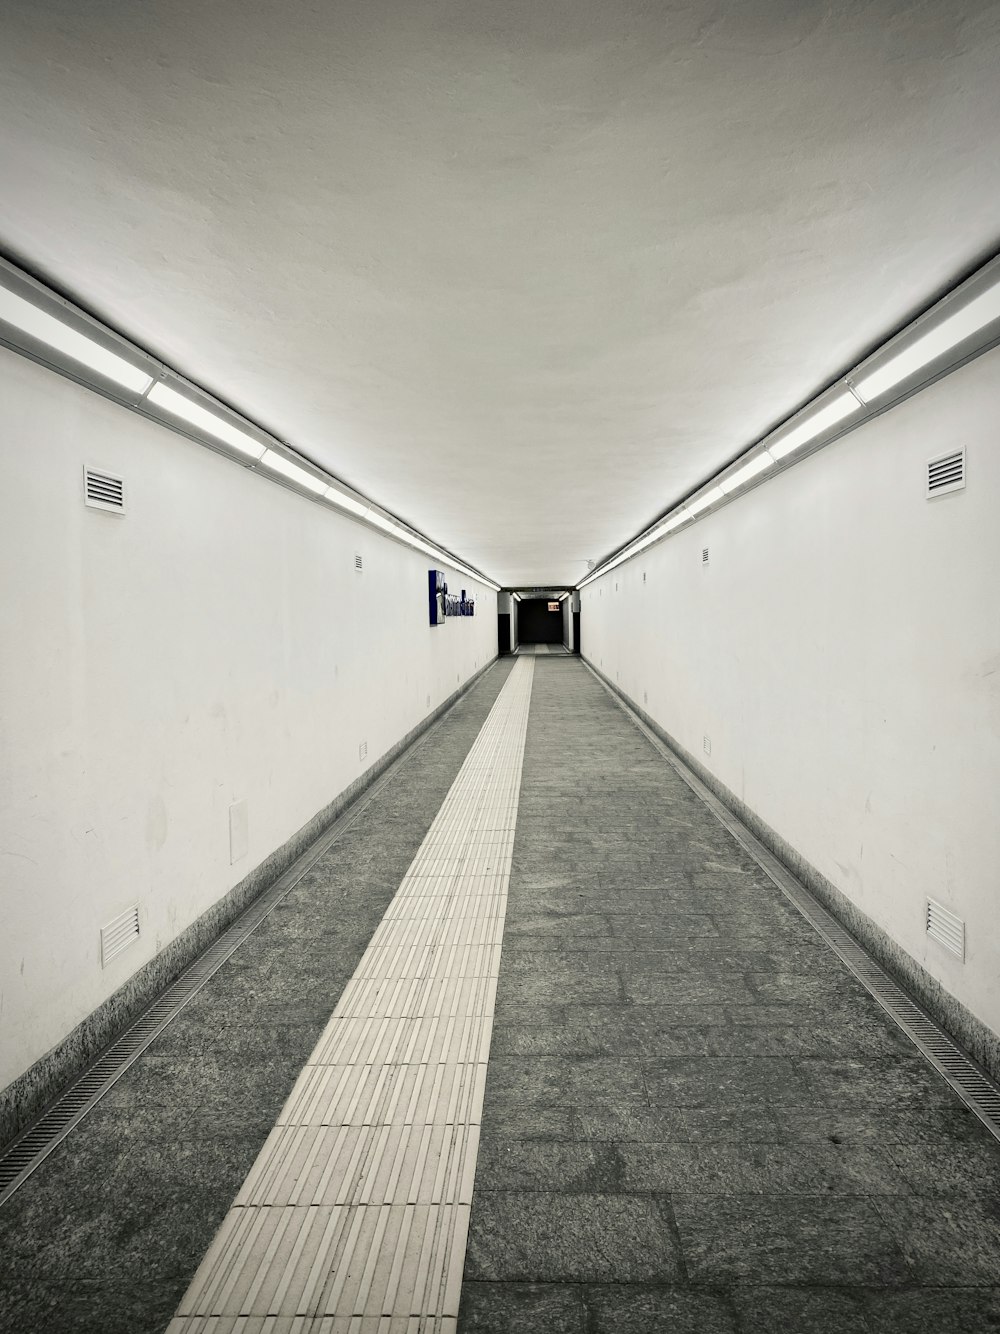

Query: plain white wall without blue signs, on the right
[581,351,1000,1033]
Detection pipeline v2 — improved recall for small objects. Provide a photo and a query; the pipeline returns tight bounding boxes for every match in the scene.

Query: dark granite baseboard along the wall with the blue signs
[0,659,497,1146]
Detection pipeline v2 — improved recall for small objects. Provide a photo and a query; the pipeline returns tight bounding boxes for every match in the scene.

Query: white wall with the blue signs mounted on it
[0,350,496,1087]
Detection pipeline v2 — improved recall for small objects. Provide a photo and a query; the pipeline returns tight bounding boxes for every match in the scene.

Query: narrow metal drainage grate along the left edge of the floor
[0,663,495,1205]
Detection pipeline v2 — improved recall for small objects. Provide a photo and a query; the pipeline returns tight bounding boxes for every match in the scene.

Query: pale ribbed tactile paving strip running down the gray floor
[168,659,533,1334]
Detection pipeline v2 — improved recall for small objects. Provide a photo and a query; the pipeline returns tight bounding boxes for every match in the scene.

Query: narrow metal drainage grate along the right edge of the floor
[588,664,1000,1139]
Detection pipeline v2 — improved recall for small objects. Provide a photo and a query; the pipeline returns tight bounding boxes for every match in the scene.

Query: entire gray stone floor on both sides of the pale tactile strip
[0,655,1000,1334]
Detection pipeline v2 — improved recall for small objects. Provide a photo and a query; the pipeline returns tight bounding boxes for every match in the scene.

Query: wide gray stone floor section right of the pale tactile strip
[459,656,1000,1334]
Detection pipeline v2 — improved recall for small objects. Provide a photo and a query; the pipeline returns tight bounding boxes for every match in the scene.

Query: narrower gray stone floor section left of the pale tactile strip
[0,660,512,1334]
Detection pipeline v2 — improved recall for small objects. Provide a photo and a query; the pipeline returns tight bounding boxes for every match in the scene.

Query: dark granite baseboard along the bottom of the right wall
[584,658,1000,1081]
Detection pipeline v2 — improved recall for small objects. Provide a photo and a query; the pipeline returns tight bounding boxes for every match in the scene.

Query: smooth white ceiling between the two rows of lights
[0,0,1000,586]
